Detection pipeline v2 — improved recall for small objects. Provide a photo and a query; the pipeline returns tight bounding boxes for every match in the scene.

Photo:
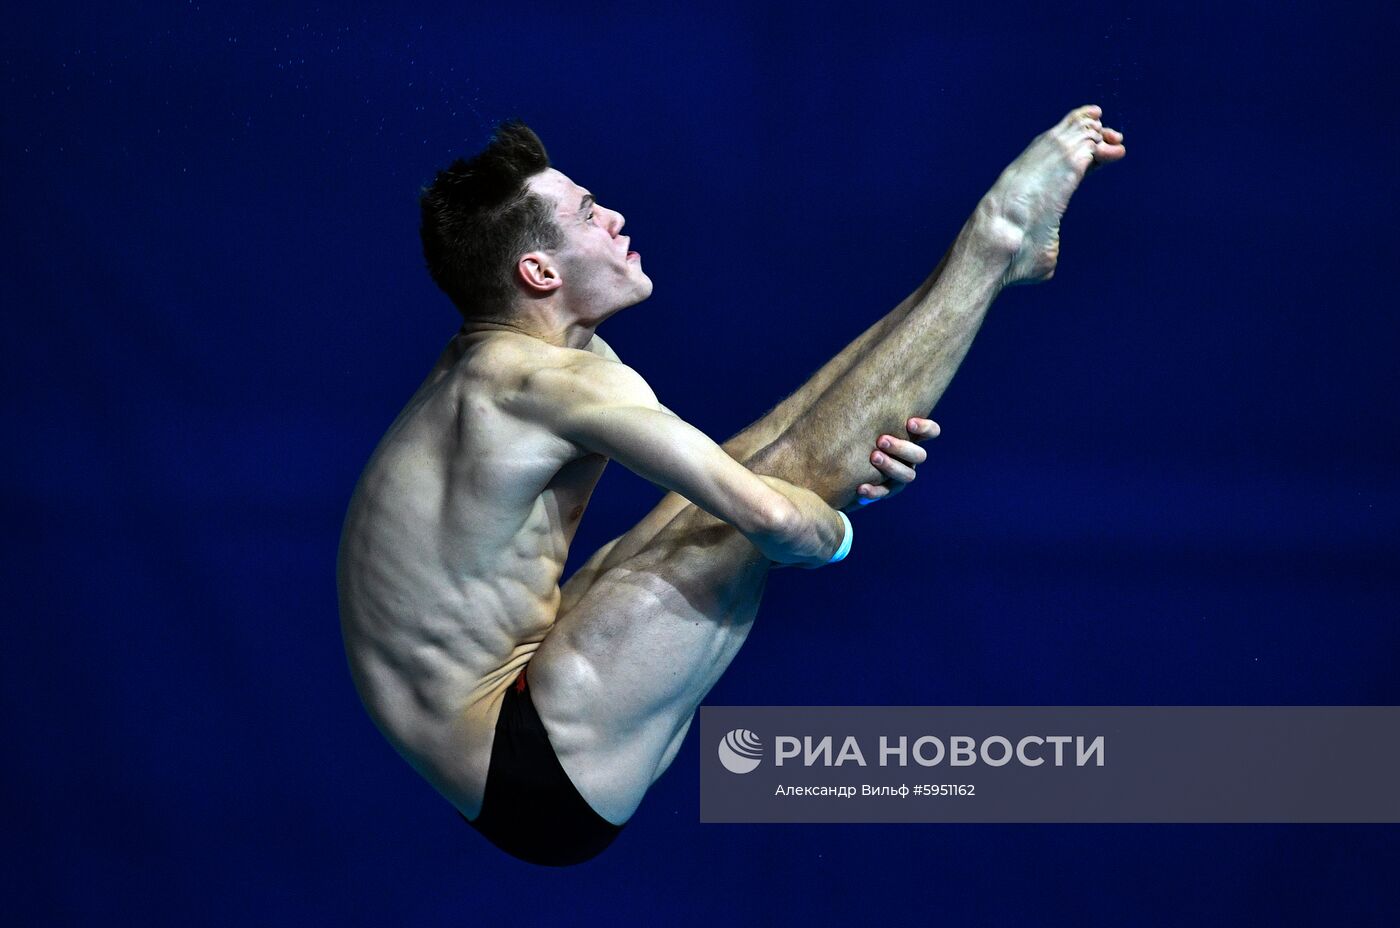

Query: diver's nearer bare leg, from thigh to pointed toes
[529,108,1121,822]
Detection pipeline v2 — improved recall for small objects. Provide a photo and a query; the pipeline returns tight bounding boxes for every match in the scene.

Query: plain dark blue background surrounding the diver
[10,3,1400,925]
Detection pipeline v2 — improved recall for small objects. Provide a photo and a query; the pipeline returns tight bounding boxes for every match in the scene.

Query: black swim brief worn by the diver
[462,670,622,866]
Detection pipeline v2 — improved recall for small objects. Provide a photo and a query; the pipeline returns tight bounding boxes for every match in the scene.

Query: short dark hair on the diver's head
[419,119,564,319]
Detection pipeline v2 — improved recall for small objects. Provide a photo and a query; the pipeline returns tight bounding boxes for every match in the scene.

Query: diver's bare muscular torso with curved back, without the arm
[337,332,608,816]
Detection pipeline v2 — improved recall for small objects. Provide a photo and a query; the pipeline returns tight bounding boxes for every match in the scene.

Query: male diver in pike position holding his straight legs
[337,106,1126,865]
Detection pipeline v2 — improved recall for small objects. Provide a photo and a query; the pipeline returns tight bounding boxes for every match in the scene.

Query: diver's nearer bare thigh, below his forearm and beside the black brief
[529,522,769,822]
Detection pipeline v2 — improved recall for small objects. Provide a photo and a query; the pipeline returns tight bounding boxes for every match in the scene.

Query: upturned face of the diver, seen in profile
[528,168,651,316]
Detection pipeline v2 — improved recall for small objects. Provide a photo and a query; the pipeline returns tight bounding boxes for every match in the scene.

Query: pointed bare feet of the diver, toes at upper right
[977,105,1127,286]
